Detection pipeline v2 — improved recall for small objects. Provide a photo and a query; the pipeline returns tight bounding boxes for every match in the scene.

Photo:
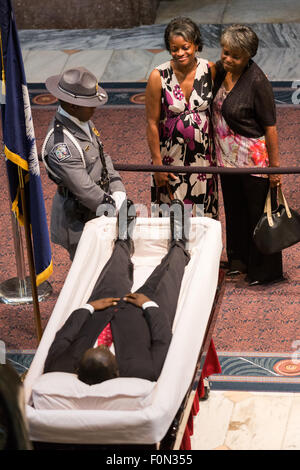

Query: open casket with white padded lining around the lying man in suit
[24,216,222,449]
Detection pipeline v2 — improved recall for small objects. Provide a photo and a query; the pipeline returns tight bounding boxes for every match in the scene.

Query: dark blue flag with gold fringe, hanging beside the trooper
[0,0,53,285]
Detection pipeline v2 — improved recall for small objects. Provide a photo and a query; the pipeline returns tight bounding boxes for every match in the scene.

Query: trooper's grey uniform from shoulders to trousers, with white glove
[42,112,126,255]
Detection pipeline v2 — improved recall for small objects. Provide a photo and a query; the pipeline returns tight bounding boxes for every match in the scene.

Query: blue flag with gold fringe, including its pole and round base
[0,0,53,341]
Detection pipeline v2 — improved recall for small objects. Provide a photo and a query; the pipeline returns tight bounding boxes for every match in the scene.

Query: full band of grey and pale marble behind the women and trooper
[19,23,300,83]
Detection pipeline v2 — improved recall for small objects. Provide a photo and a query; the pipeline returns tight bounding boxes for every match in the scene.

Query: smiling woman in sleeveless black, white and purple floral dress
[146,18,218,217]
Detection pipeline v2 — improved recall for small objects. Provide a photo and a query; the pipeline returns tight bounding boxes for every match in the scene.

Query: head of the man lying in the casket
[77,345,119,385]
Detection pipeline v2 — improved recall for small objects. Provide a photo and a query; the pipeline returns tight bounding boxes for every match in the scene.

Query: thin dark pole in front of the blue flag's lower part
[18,167,43,342]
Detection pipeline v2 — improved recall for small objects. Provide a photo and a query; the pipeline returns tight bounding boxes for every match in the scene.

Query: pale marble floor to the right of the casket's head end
[191,391,300,450]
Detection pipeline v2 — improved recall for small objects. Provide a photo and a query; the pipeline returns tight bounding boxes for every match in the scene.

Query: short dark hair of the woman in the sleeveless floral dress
[164,16,203,52]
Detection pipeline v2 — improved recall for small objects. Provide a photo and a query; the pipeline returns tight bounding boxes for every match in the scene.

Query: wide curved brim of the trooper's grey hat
[45,75,108,108]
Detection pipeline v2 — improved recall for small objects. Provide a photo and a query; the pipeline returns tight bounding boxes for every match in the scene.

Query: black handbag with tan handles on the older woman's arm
[253,186,300,255]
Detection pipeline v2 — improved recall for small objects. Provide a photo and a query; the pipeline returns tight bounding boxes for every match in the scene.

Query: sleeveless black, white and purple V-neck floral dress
[151,58,218,217]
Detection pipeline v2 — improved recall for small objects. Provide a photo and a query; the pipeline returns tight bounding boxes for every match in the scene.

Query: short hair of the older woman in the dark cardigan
[220,24,259,57]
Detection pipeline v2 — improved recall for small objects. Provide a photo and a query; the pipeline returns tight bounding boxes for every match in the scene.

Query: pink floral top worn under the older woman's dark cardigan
[212,85,269,178]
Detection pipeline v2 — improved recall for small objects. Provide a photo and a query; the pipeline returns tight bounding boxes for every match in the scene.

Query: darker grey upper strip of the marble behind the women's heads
[19,23,300,50]
